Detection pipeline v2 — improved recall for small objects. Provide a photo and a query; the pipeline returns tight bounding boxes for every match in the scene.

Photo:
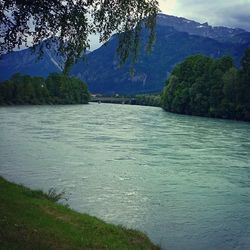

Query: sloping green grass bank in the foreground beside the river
[0,177,159,250]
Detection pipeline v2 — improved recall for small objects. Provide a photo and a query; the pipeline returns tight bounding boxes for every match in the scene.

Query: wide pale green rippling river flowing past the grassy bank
[0,104,250,250]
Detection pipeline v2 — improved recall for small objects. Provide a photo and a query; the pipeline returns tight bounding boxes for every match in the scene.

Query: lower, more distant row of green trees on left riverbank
[0,73,90,105]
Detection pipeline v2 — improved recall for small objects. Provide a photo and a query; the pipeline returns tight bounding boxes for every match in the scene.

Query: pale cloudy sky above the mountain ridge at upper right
[159,0,250,31]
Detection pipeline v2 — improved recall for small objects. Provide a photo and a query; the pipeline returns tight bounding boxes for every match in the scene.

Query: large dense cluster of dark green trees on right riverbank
[162,48,250,121]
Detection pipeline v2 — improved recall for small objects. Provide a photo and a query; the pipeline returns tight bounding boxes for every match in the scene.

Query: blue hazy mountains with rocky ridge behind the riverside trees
[0,14,250,94]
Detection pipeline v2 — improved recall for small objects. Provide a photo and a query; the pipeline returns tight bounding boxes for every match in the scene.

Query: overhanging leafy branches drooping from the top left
[0,0,159,71]
